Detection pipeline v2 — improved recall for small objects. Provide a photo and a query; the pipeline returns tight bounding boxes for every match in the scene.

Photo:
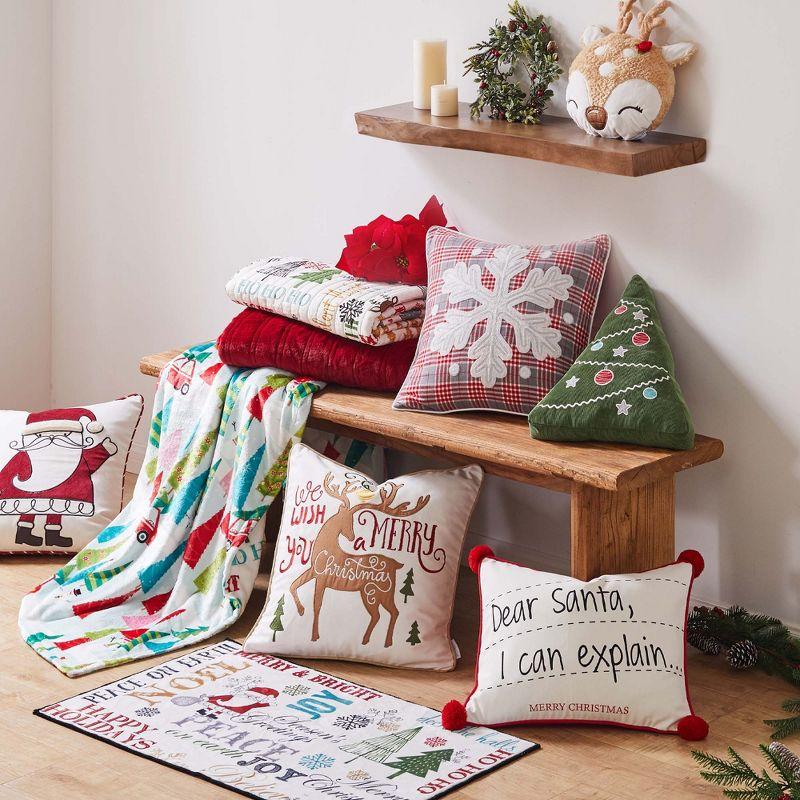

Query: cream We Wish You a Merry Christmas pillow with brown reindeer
[244,444,483,670]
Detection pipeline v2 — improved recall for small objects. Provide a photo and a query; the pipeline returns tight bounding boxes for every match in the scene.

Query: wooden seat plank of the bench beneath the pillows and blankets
[140,350,723,492]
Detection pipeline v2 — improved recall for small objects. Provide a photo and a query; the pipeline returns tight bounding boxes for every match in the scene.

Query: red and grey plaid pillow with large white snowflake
[394,227,611,414]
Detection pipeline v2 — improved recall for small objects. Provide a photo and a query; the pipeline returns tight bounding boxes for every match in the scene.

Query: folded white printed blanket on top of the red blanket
[225,258,426,345]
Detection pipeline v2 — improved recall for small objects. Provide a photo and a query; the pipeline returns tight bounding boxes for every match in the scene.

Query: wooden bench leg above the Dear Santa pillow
[571,476,675,581]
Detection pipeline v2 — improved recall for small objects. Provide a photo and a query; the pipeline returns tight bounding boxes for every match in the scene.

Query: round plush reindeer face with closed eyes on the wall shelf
[566,0,697,139]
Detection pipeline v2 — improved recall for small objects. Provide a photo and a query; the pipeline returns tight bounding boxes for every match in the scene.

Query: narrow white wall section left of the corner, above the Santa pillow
[0,0,51,409]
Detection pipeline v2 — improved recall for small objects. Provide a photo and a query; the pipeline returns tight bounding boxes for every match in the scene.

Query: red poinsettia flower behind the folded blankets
[336,196,447,285]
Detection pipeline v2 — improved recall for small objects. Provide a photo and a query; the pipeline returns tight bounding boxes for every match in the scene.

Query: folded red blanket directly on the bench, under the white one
[217,308,417,392]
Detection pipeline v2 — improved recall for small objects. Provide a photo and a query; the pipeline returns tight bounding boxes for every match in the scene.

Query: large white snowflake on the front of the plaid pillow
[430,246,573,388]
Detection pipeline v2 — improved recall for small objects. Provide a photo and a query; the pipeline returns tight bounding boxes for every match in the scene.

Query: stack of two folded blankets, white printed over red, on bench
[217,258,426,391]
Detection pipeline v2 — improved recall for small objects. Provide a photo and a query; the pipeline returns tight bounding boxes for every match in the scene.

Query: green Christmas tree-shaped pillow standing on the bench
[528,275,694,450]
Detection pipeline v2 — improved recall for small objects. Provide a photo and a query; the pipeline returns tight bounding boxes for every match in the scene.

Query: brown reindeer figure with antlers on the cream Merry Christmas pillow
[289,472,430,647]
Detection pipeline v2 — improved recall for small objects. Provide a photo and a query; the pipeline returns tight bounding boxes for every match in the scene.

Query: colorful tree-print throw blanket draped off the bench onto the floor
[19,344,323,677]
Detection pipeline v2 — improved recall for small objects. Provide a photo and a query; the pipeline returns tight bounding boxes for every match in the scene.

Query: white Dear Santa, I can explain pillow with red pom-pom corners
[442,546,708,739]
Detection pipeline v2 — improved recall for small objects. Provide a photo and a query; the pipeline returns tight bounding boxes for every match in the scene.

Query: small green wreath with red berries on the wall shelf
[464,0,563,125]
